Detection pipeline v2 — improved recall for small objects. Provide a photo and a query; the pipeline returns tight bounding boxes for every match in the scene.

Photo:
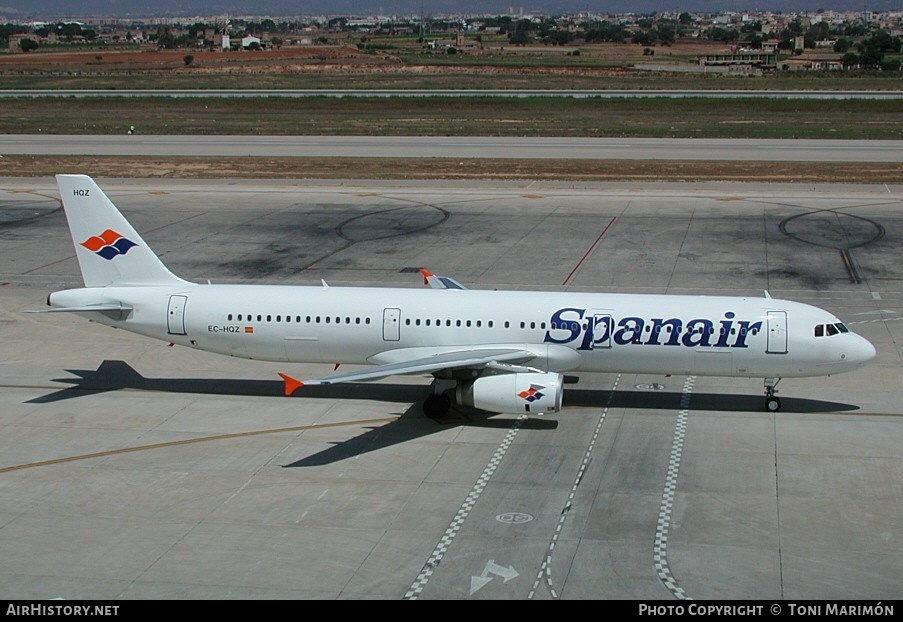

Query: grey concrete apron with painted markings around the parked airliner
[0,178,903,601]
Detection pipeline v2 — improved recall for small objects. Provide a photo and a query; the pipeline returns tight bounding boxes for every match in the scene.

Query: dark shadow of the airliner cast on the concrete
[28,360,859,467]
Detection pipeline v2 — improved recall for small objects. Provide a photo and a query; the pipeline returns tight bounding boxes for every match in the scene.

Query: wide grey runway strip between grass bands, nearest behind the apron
[0,134,903,163]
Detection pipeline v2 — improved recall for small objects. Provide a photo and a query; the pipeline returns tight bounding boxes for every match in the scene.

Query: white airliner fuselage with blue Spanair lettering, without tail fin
[51,283,874,377]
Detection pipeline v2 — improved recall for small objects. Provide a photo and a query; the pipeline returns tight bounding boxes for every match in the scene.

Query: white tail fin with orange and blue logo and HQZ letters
[56,175,186,287]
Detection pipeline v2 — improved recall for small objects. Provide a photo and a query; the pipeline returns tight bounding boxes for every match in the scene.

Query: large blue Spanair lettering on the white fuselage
[543,307,762,351]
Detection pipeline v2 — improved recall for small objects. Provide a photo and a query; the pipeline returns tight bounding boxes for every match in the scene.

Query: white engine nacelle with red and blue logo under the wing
[455,372,564,415]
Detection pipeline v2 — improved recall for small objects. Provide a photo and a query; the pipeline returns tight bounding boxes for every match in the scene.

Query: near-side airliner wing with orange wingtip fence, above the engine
[279,348,537,395]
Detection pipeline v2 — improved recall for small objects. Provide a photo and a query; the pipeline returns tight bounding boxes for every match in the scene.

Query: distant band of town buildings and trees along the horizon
[0,9,903,71]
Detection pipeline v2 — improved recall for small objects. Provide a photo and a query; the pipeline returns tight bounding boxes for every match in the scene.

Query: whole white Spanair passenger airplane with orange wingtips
[33,175,875,418]
